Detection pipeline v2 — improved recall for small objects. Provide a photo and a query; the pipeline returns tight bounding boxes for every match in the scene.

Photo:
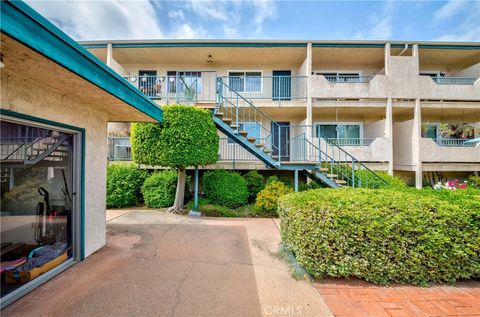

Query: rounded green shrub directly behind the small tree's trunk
[142,170,188,208]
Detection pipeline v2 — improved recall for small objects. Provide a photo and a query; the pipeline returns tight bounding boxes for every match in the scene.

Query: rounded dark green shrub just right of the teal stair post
[203,170,248,208]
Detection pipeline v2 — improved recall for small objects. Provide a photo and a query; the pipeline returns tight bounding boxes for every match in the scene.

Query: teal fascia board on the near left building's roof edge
[0,1,163,121]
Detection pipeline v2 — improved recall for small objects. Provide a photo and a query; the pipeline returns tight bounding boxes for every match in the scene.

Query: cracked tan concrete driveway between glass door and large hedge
[2,210,332,316]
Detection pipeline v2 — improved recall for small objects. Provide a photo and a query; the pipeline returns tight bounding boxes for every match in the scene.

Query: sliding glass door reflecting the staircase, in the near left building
[0,116,81,306]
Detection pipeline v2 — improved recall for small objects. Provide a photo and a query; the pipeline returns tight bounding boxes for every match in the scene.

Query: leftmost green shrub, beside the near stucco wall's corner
[107,164,148,208]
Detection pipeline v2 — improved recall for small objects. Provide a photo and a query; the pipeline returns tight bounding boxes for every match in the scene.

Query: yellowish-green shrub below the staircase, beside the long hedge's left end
[255,181,293,215]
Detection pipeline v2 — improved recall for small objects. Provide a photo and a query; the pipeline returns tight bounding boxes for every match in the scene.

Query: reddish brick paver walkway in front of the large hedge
[315,279,480,317]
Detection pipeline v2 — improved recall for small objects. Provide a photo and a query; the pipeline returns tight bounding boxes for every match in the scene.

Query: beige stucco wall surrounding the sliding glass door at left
[0,71,107,256]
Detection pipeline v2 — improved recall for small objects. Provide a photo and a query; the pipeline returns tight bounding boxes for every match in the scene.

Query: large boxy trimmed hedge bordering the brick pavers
[278,188,480,285]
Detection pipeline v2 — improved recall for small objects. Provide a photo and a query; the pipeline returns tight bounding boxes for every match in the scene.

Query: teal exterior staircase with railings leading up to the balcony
[213,78,385,188]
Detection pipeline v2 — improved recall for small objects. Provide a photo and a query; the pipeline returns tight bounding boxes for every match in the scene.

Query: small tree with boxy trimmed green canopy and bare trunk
[131,105,218,212]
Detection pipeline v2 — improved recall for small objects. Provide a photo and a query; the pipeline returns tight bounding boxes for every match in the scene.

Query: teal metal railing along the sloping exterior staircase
[214,78,386,188]
